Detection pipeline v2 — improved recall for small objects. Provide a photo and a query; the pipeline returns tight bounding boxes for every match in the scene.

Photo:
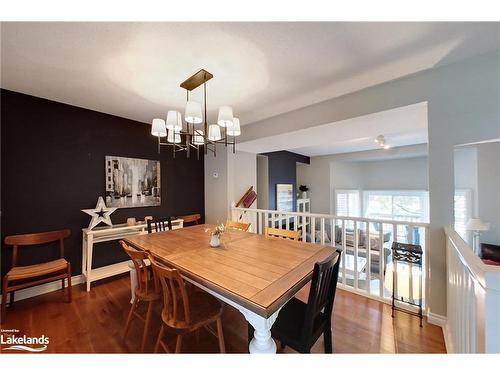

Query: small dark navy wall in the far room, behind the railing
[262,151,310,210]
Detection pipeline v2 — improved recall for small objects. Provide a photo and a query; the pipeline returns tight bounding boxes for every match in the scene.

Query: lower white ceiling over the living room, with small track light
[237,102,428,156]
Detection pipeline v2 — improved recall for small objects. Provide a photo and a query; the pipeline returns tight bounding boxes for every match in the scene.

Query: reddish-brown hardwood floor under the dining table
[1,277,446,353]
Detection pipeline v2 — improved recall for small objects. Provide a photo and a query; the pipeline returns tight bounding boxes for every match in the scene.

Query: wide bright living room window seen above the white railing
[363,190,429,222]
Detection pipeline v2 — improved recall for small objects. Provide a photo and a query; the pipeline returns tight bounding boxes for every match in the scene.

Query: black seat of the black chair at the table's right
[271,298,324,350]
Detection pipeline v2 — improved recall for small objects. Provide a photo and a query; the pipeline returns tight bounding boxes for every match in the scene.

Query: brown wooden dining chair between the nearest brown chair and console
[119,240,161,352]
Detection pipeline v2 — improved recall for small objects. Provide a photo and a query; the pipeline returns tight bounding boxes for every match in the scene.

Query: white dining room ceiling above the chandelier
[1,22,500,124]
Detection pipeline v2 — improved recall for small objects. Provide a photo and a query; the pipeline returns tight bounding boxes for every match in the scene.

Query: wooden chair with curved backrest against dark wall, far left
[2,229,71,317]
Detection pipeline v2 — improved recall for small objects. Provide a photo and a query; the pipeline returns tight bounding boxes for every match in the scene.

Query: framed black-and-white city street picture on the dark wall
[106,156,161,208]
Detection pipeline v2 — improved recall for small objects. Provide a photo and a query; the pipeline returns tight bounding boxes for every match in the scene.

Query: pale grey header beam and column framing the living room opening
[241,51,500,315]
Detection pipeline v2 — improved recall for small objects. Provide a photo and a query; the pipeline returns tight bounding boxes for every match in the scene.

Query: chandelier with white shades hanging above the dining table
[151,69,241,158]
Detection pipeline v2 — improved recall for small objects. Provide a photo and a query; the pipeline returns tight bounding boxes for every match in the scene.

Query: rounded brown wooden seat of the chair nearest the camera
[161,291,223,330]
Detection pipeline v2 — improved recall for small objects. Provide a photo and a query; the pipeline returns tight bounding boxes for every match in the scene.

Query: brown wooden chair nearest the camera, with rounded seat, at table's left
[149,254,226,353]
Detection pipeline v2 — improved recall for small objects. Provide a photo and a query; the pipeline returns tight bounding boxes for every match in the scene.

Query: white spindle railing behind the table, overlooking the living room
[232,207,429,311]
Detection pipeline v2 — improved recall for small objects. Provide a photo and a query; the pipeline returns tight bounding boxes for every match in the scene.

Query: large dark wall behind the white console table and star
[0,90,204,277]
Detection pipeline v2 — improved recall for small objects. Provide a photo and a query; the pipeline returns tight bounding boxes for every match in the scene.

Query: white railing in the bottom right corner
[445,228,500,353]
